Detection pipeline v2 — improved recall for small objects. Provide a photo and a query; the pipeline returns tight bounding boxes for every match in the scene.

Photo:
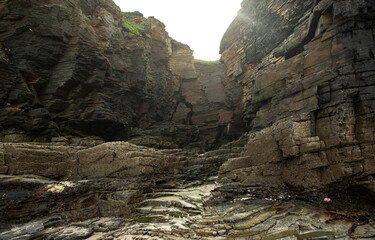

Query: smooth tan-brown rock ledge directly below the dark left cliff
[0,142,194,179]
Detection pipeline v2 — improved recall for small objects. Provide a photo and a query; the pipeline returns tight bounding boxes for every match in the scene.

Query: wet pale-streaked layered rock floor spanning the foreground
[0,172,375,239]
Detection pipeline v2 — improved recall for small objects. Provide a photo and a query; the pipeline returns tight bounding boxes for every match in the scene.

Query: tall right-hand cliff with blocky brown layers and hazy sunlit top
[221,0,375,192]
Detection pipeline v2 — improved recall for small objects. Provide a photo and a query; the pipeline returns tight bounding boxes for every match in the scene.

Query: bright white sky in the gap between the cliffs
[114,0,242,61]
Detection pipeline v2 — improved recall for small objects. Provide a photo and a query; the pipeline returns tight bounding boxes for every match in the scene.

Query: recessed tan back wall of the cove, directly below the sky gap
[129,59,243,152]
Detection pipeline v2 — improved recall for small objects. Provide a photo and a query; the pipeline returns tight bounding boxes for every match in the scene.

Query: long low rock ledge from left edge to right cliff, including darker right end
[0,136,245,181]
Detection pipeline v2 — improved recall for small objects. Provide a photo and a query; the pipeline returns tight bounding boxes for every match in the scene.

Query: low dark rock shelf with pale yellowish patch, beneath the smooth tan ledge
[0,175,140,223]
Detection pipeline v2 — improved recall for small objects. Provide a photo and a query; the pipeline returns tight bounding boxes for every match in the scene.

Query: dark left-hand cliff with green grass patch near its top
[0,0,242,150]
